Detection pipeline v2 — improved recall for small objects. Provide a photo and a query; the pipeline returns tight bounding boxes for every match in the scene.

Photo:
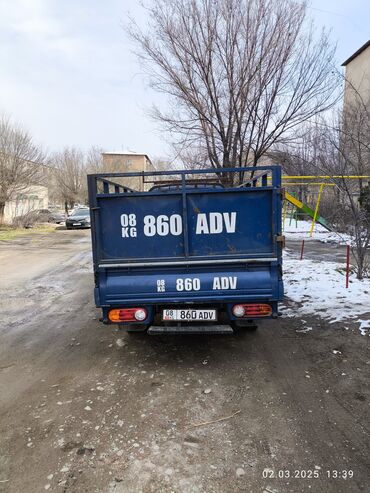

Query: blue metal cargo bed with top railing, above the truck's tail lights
[88,166,283,321]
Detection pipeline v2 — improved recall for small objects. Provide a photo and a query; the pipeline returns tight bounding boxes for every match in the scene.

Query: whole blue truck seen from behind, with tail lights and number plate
[88,166,283,330]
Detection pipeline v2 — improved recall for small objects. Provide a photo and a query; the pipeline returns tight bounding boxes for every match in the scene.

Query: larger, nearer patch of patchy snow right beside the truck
[283,250,370,335]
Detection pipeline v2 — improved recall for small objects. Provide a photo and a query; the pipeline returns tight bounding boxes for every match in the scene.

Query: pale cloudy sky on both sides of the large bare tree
[0,0,370,157]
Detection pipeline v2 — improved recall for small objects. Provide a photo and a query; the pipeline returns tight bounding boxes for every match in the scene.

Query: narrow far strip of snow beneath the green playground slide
[283,219,351,245]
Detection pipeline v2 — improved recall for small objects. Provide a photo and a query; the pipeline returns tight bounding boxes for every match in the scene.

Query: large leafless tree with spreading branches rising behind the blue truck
[129,0,338,180]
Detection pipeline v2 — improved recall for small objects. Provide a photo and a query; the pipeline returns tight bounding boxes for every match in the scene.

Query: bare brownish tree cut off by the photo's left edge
[0,117,46,223]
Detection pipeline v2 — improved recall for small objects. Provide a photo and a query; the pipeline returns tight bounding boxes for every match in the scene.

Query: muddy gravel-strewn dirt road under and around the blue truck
[0,230,370,493]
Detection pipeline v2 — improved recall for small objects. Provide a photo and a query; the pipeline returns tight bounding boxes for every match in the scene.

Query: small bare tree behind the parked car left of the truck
[51,147,87,213]
